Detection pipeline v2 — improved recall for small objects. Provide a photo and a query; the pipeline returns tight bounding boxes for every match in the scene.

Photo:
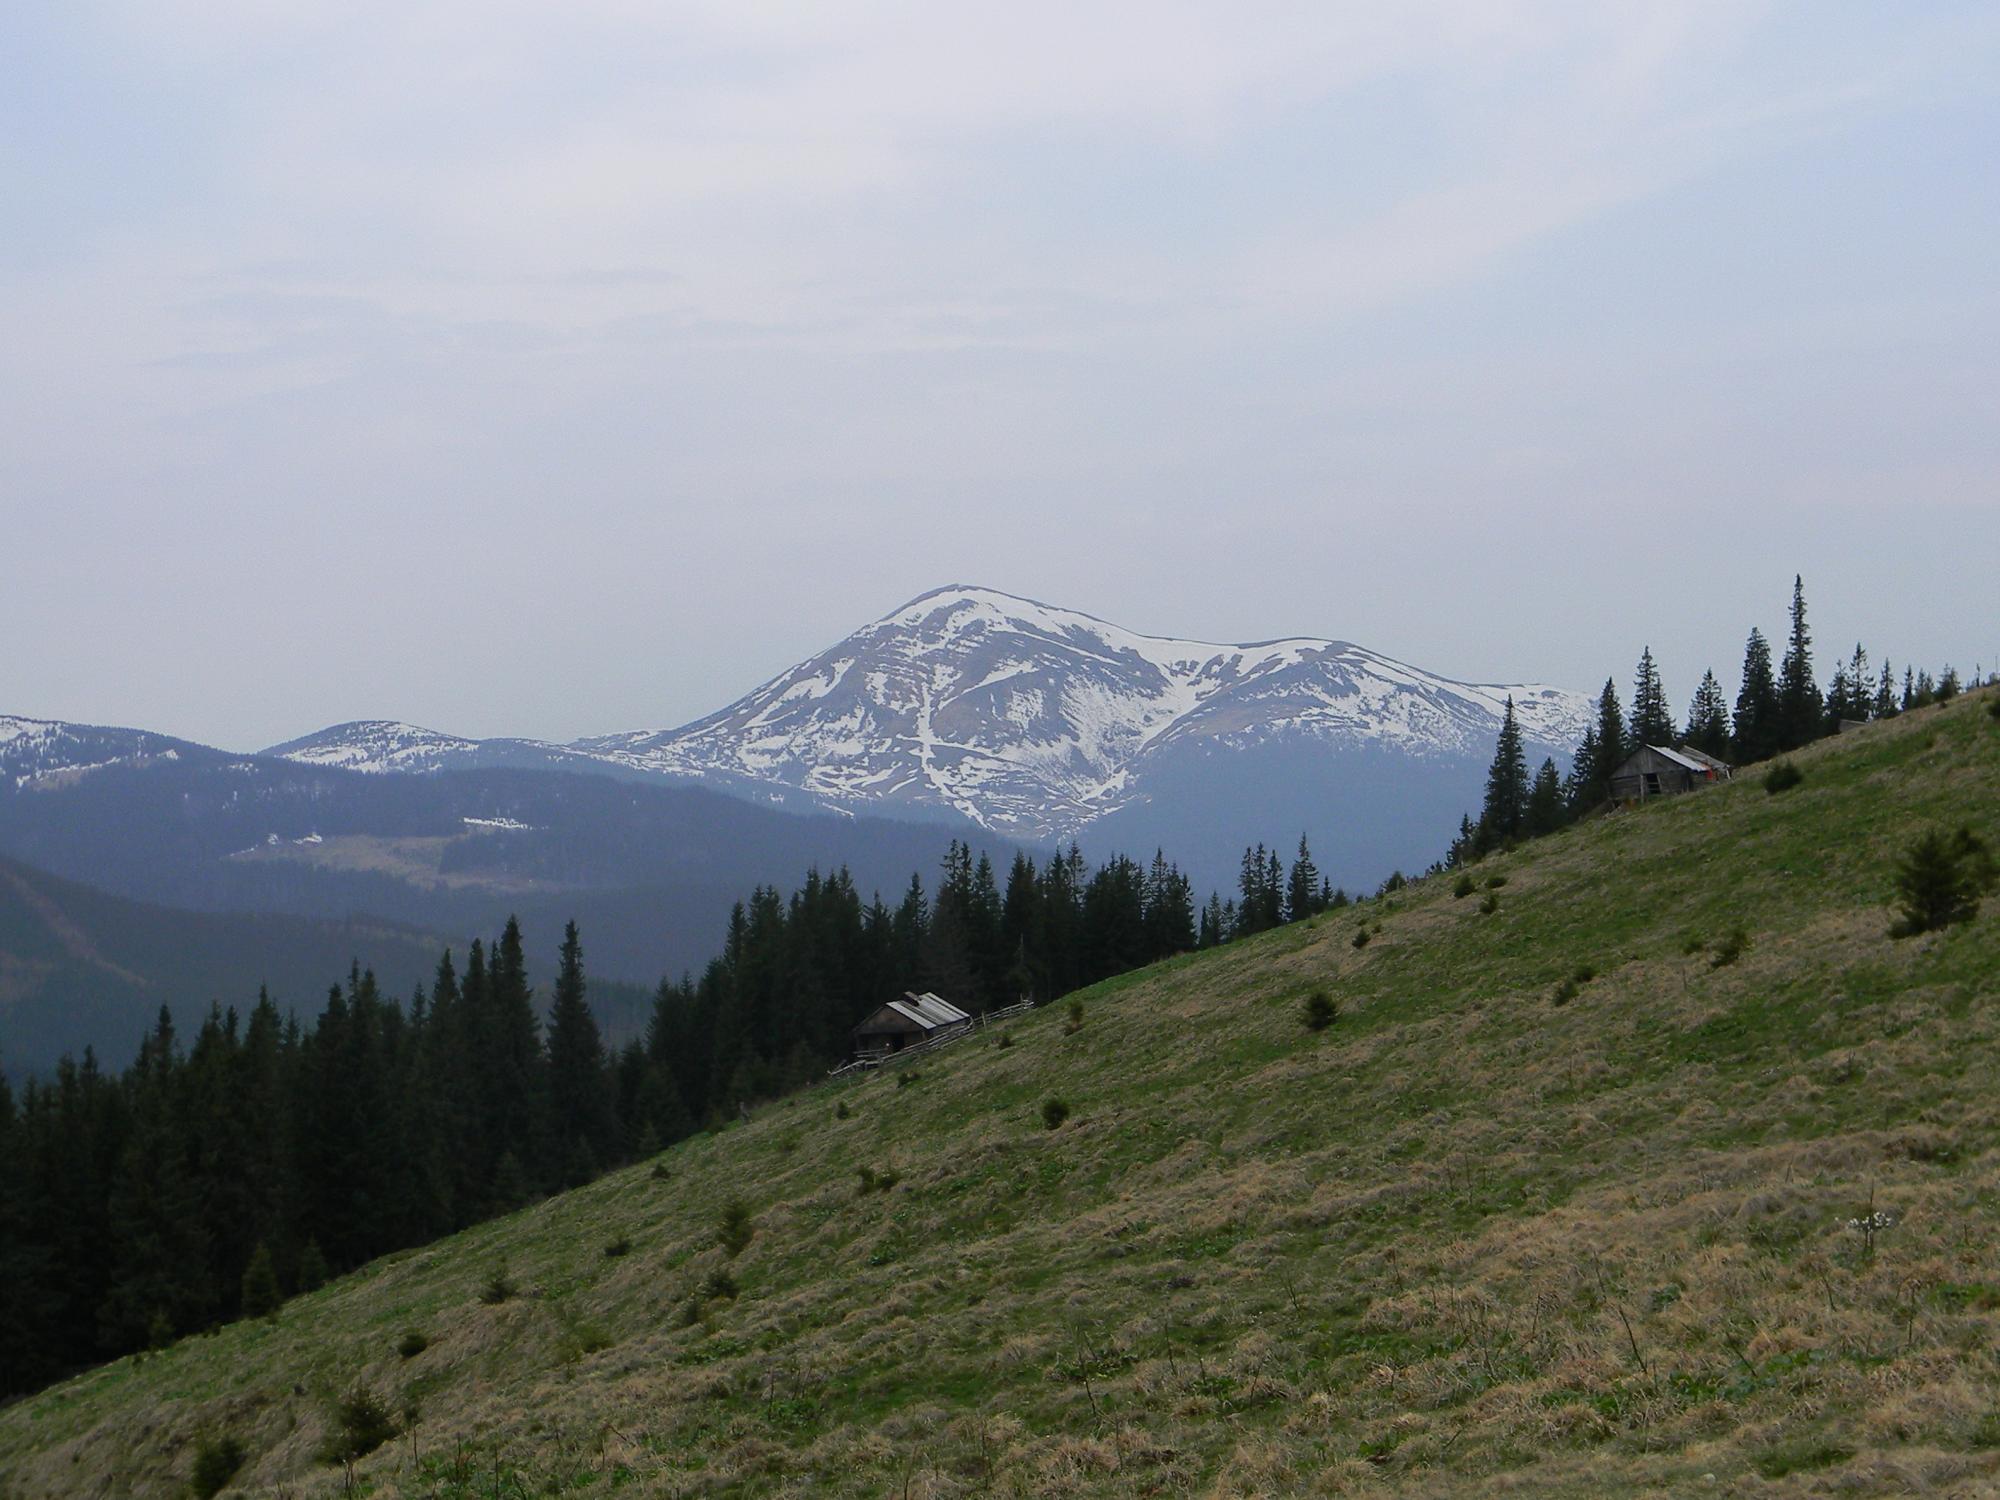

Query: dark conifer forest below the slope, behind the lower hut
[0,842,1346,1394]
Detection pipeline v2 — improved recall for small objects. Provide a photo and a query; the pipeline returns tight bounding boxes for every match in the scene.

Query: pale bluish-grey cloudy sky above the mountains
[0,0,2000,750]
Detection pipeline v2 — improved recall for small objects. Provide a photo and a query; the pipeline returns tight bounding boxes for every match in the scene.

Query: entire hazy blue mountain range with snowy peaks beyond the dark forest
[0,586,1592,956]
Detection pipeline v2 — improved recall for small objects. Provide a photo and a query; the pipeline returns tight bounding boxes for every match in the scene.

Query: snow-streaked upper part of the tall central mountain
[570,586,1590,840]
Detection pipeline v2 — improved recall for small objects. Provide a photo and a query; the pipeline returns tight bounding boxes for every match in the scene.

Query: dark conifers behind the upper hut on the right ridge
[1442,576,1962,866]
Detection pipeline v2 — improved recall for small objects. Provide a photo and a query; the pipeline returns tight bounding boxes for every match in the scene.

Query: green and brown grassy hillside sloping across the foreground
[0,692,2000,1496]
